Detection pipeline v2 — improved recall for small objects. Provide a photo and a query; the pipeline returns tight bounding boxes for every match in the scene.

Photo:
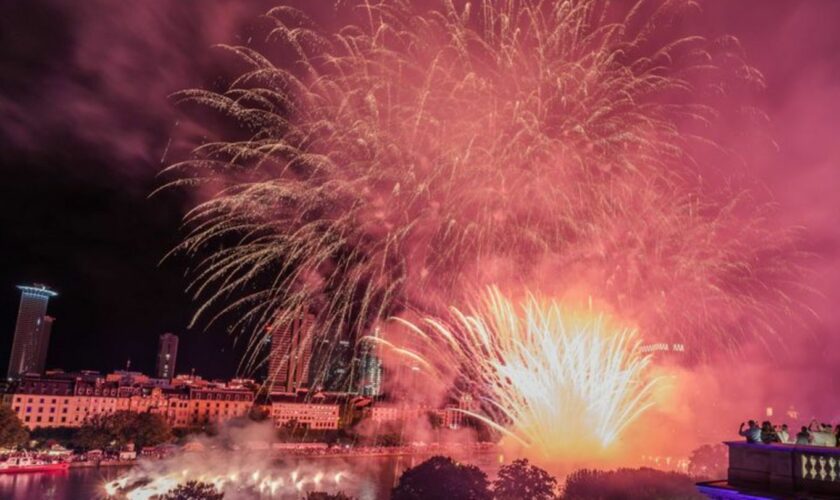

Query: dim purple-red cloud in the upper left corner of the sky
[0,0,270,177]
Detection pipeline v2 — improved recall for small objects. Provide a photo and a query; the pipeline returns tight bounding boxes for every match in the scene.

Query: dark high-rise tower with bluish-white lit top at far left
[8,284,58,379]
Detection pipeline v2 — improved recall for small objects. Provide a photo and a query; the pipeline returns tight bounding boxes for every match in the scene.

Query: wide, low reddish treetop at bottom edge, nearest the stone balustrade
[563,467,706,500]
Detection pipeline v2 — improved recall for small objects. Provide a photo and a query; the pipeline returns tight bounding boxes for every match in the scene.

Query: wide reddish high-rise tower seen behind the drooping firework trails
[268,312,315,392]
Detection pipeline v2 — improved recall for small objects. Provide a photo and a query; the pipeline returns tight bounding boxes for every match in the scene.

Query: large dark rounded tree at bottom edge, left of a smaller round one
[391,456,493,500]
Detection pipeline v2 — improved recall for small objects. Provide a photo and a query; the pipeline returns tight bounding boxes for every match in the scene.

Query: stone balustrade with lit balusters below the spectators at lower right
[698,442,840,498]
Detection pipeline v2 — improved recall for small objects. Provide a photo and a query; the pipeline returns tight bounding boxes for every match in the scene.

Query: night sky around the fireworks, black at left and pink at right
[0,0,840,377]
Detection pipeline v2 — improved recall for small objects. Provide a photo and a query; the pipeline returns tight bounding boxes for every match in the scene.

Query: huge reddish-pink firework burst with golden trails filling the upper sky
[166,0,793,376]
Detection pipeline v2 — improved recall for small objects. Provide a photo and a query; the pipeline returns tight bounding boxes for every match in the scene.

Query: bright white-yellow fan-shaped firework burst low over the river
[386,288,655,461]
